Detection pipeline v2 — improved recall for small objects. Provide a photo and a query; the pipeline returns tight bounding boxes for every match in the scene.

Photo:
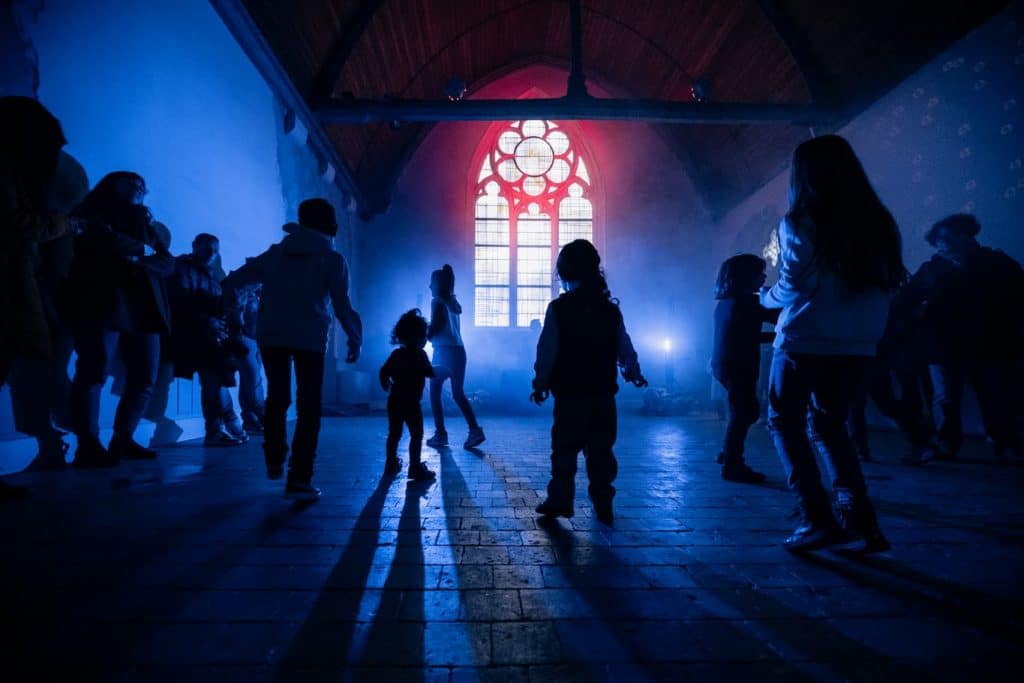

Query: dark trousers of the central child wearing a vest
[548,393,618,506]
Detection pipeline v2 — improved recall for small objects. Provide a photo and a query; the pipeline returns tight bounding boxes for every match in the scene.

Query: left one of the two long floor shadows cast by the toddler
[273,477,394,681]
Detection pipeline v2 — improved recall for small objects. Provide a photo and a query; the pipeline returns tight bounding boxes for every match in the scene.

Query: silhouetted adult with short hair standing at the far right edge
[907,214,1024,461]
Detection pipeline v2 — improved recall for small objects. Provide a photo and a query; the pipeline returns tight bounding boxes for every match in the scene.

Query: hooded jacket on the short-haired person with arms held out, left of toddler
[221,223,362,353]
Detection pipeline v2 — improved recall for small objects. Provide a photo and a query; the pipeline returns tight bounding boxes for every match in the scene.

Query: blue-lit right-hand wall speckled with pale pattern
[717,0,1024,268]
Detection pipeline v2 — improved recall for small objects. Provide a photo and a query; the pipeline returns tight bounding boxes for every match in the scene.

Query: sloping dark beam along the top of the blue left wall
[210,0,368,210]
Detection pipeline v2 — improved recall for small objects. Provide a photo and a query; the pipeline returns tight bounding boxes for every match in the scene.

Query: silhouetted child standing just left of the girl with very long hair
[711,254,779,483]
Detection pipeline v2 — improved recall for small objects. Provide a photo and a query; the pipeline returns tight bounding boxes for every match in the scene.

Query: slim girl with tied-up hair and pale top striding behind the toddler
[427,263,485,449]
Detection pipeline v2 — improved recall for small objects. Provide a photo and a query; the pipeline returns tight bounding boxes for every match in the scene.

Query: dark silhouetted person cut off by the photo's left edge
[0,97,75,499]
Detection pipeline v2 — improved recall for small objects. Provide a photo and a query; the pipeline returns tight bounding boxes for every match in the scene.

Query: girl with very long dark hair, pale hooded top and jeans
[761,135,907,552]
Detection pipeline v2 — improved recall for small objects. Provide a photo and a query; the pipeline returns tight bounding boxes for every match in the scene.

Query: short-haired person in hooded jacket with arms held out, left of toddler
[222,199,362,500]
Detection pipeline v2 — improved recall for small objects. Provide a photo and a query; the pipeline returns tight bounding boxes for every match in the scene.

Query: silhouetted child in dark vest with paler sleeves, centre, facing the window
[530,240,647,524]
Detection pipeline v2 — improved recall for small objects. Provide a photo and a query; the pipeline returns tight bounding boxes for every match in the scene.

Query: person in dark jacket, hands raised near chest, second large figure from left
[59,171,174,467]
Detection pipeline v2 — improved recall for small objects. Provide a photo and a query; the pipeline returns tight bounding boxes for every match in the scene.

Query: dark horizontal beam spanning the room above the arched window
[315,97,836,126]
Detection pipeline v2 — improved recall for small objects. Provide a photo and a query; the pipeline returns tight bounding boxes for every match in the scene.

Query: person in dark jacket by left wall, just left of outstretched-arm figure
[167,232,249,446]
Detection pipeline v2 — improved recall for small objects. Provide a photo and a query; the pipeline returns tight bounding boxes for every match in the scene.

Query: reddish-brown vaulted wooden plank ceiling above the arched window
[237,0,1007,215]
